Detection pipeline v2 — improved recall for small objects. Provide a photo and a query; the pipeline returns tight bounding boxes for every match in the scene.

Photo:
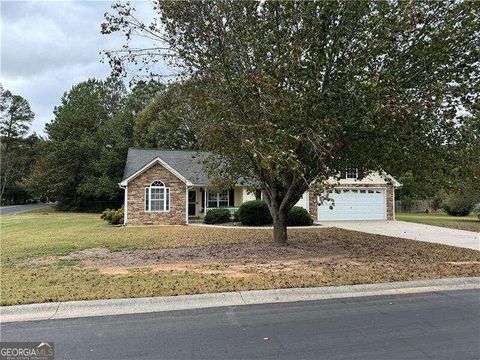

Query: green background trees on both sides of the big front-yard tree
[0,71,480,215]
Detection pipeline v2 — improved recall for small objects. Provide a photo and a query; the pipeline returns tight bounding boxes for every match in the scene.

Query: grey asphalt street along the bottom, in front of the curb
[1,290,480,360]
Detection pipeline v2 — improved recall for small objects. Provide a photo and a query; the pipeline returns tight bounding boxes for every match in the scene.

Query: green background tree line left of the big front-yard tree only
[1,77,197,211]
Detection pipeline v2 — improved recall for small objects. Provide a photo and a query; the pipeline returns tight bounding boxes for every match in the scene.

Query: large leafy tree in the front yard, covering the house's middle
[102,0,480,244]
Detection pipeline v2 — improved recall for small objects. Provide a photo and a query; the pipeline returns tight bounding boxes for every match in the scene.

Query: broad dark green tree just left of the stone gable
[29,78,163,211]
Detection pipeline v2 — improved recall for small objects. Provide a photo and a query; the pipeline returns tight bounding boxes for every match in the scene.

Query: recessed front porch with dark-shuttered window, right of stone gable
[187,185,256,222]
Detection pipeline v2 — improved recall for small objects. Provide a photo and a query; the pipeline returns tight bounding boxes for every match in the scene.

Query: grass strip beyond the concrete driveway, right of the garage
[395,213,480,232]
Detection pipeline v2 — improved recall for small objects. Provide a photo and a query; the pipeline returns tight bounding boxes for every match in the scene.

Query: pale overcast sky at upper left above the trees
[0,0,151,134]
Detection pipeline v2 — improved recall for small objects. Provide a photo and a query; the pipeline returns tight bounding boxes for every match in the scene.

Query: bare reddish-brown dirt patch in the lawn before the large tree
[28,243,352,278]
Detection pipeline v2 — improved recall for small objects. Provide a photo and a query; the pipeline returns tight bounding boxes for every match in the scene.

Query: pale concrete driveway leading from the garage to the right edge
[321,221,480,250]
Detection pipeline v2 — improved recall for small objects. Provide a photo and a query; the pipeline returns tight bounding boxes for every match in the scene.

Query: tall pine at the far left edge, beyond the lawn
[0,84,36,201]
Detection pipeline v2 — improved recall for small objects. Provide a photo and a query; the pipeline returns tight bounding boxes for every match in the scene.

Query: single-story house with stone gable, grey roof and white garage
[119,149,401,224]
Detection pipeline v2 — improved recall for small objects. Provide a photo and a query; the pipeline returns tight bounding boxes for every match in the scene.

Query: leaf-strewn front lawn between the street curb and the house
[0,210,480,305]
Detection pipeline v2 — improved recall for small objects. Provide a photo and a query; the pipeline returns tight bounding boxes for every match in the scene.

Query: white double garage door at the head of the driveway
[318,189,386,221]
